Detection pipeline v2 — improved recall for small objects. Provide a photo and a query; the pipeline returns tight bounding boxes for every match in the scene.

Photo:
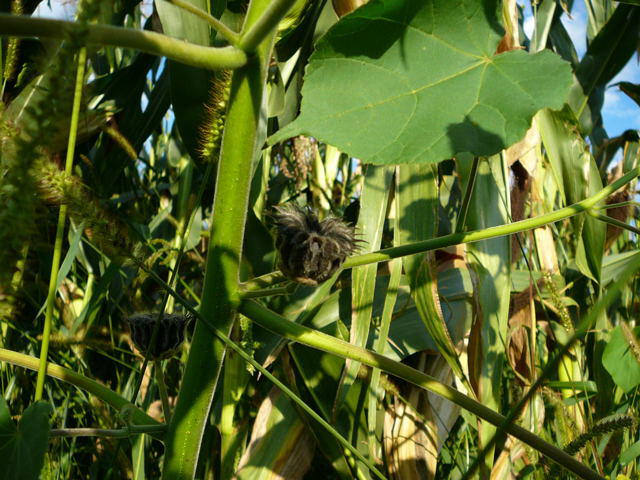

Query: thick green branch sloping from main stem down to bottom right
[239,300,603,480]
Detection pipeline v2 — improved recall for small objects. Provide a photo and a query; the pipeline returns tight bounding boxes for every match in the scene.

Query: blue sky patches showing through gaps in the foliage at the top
[38,0,640,137]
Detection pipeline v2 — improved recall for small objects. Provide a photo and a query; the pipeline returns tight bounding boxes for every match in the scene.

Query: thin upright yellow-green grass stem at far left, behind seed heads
[35,48,87,402]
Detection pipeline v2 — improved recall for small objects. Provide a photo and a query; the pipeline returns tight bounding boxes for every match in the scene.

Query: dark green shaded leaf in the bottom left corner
[0,397,51,480]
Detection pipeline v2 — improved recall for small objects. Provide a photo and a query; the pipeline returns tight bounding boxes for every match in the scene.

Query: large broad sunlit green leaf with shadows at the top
[271,0,572,164]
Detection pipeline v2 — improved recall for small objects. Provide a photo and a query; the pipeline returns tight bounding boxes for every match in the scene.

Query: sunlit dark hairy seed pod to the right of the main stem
[272,205,356,285]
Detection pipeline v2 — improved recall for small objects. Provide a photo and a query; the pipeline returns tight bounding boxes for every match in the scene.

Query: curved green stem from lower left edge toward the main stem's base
[0,348,162,438]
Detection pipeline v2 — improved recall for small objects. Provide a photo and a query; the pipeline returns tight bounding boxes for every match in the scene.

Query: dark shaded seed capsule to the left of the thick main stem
[126,313,190,360]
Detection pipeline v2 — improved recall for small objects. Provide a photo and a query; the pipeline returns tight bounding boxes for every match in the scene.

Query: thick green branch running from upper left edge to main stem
[0,14,247,70]
